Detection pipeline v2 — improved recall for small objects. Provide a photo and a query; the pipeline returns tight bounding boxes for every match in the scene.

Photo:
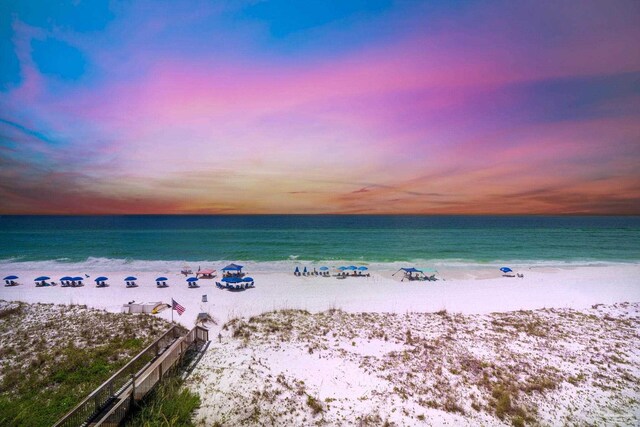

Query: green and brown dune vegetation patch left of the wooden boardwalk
[0,302,167,426]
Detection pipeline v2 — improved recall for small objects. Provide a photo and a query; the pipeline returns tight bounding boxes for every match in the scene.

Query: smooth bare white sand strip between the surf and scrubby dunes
[0,263,640,333]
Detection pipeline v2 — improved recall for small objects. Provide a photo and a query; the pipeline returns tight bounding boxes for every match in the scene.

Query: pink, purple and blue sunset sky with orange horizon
[0,0,640,215]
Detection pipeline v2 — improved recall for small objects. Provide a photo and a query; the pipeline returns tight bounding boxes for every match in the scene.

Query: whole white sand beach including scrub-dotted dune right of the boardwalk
[0,264,640,425]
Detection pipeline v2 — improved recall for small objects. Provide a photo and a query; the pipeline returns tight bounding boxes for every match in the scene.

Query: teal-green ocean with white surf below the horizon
[0,215,640,271]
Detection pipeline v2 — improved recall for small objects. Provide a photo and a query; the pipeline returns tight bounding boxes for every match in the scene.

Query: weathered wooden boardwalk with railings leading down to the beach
[54,326,209,427]
